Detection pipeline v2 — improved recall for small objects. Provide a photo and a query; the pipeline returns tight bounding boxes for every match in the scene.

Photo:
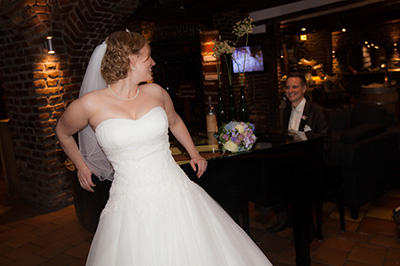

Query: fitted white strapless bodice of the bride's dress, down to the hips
[96,107,189,212]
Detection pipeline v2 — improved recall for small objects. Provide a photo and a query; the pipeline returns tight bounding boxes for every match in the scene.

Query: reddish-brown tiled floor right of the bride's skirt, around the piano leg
[250,189,400,266]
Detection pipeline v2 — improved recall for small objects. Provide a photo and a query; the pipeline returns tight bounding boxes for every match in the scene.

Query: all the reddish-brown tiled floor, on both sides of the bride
[0,176,400,266]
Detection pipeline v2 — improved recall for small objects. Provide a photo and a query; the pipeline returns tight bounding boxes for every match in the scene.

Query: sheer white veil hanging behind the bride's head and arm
[78,42,114,181]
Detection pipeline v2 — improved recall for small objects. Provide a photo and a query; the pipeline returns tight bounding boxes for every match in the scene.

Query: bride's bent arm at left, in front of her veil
[56,98,96,192]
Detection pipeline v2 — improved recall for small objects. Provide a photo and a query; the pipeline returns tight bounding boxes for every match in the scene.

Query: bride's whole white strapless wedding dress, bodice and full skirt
[87,107,271,266]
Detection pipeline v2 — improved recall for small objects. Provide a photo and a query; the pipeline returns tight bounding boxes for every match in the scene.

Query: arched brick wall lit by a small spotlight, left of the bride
[0,0,141,209]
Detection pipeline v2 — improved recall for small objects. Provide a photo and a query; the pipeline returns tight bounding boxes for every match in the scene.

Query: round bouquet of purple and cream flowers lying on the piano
[216,121,257,153]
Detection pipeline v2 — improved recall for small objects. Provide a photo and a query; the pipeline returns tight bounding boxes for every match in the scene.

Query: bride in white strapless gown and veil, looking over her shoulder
[56,31,271,266]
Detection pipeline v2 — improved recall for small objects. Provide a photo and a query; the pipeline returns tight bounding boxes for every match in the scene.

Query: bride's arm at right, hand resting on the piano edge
[163,90,207,177]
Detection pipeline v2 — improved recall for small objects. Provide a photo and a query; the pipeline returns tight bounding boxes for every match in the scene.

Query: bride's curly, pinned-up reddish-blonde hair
[101,31,150,84]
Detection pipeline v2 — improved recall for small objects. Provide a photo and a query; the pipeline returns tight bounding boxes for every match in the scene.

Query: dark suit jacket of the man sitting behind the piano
[282,100,331,136]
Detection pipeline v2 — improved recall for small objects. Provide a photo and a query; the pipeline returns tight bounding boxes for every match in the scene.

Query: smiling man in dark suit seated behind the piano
[268,72,331,232]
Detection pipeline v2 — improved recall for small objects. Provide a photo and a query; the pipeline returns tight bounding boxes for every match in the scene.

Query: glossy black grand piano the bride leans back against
[73,131,323,265]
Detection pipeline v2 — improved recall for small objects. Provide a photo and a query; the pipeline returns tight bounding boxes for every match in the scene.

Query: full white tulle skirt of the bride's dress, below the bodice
[87,178,271,266]
